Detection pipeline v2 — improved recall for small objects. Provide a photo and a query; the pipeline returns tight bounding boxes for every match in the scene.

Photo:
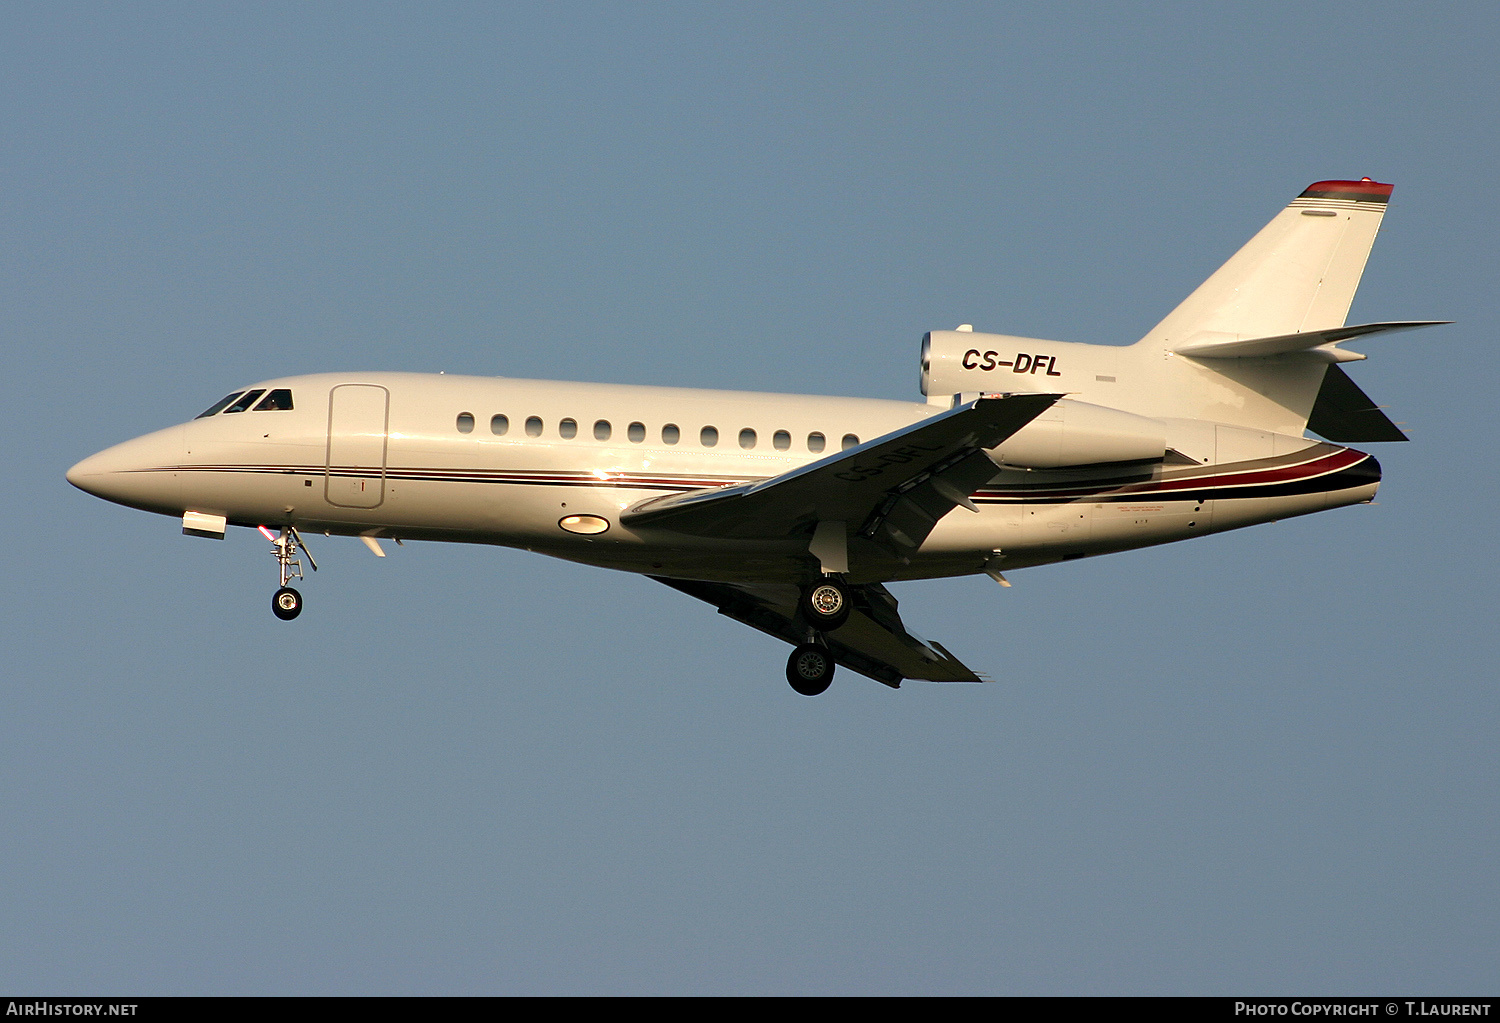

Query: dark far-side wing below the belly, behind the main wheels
[651,576,986,689]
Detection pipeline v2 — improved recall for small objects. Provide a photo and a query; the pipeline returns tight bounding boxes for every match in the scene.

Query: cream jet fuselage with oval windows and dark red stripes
[69,374,1379,582]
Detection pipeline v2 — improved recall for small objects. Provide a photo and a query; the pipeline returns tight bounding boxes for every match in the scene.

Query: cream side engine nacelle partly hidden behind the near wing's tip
[989,398,1167,470]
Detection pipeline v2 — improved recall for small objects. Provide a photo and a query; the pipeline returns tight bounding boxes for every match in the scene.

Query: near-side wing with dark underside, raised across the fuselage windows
[620,395,1062,554]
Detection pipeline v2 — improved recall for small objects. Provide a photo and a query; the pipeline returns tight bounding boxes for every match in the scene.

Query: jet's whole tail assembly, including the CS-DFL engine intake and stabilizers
[923,179,1446,447]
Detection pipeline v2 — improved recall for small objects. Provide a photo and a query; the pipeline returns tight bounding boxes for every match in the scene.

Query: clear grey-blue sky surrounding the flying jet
[0,3,1500,995]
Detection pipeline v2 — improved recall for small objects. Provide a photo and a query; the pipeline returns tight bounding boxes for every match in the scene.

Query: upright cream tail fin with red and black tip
[1142,179,1392,350]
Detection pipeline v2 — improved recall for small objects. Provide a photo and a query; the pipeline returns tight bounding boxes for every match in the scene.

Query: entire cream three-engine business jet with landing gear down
[68,179,1443,696]
